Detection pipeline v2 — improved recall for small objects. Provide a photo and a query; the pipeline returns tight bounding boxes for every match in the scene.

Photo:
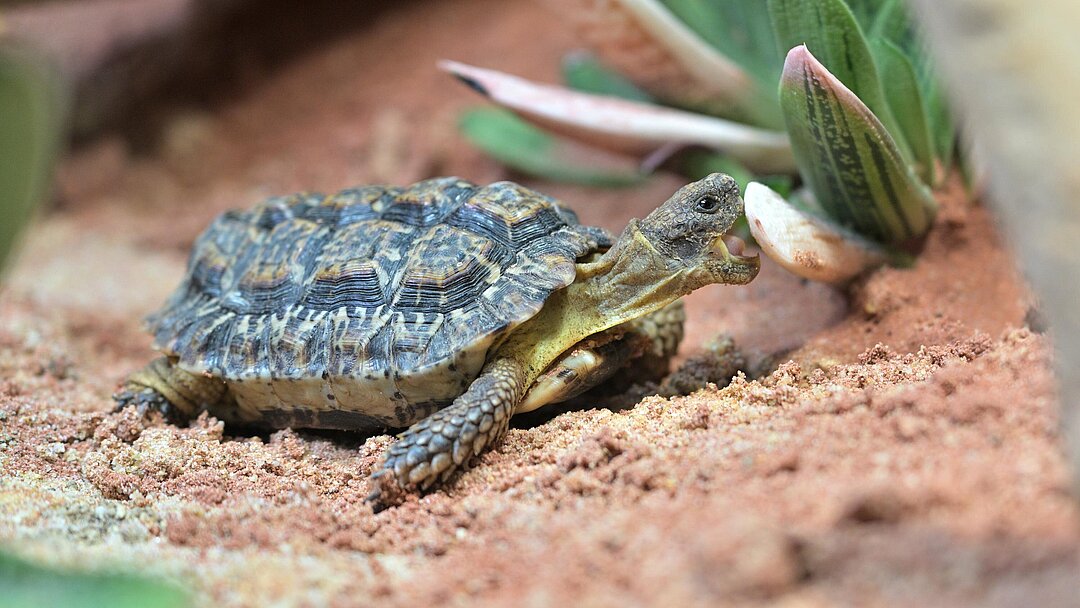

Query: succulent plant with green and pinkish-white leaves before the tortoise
[444,0,958,282]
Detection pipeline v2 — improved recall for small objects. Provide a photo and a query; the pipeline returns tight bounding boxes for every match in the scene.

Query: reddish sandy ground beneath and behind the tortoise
[0,0,1080,607]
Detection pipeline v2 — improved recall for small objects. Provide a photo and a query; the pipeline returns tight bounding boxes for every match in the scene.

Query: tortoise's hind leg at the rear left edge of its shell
[112,356,226,421]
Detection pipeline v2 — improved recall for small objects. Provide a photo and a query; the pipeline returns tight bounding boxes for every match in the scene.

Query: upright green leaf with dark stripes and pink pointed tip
[780,46,935,244]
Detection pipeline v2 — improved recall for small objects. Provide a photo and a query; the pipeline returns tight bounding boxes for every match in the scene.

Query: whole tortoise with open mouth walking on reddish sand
[116,174,759,498]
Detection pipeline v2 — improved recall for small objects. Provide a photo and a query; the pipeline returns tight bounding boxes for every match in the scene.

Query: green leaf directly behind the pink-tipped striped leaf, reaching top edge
[768,0,912,160]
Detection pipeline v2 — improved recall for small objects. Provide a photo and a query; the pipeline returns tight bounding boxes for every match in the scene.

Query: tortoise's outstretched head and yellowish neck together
[497,173,760,383]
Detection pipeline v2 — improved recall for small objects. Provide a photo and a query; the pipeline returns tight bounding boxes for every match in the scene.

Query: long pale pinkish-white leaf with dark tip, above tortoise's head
[440,62,795,172]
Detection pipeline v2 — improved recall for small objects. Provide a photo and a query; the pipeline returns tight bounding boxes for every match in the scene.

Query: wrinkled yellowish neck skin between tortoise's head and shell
[495,220,713,387]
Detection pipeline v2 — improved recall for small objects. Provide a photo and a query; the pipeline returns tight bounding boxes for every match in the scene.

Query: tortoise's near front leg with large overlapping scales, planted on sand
[368,359,526,504]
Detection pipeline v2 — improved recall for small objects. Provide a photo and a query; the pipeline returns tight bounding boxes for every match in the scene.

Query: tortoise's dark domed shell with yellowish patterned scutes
[149,178,611,429]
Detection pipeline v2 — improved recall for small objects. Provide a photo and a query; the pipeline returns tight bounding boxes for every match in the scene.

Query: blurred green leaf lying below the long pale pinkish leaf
[460,108,644,186]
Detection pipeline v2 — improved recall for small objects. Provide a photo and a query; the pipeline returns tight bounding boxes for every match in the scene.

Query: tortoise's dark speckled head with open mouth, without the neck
[638,173,760,285]
